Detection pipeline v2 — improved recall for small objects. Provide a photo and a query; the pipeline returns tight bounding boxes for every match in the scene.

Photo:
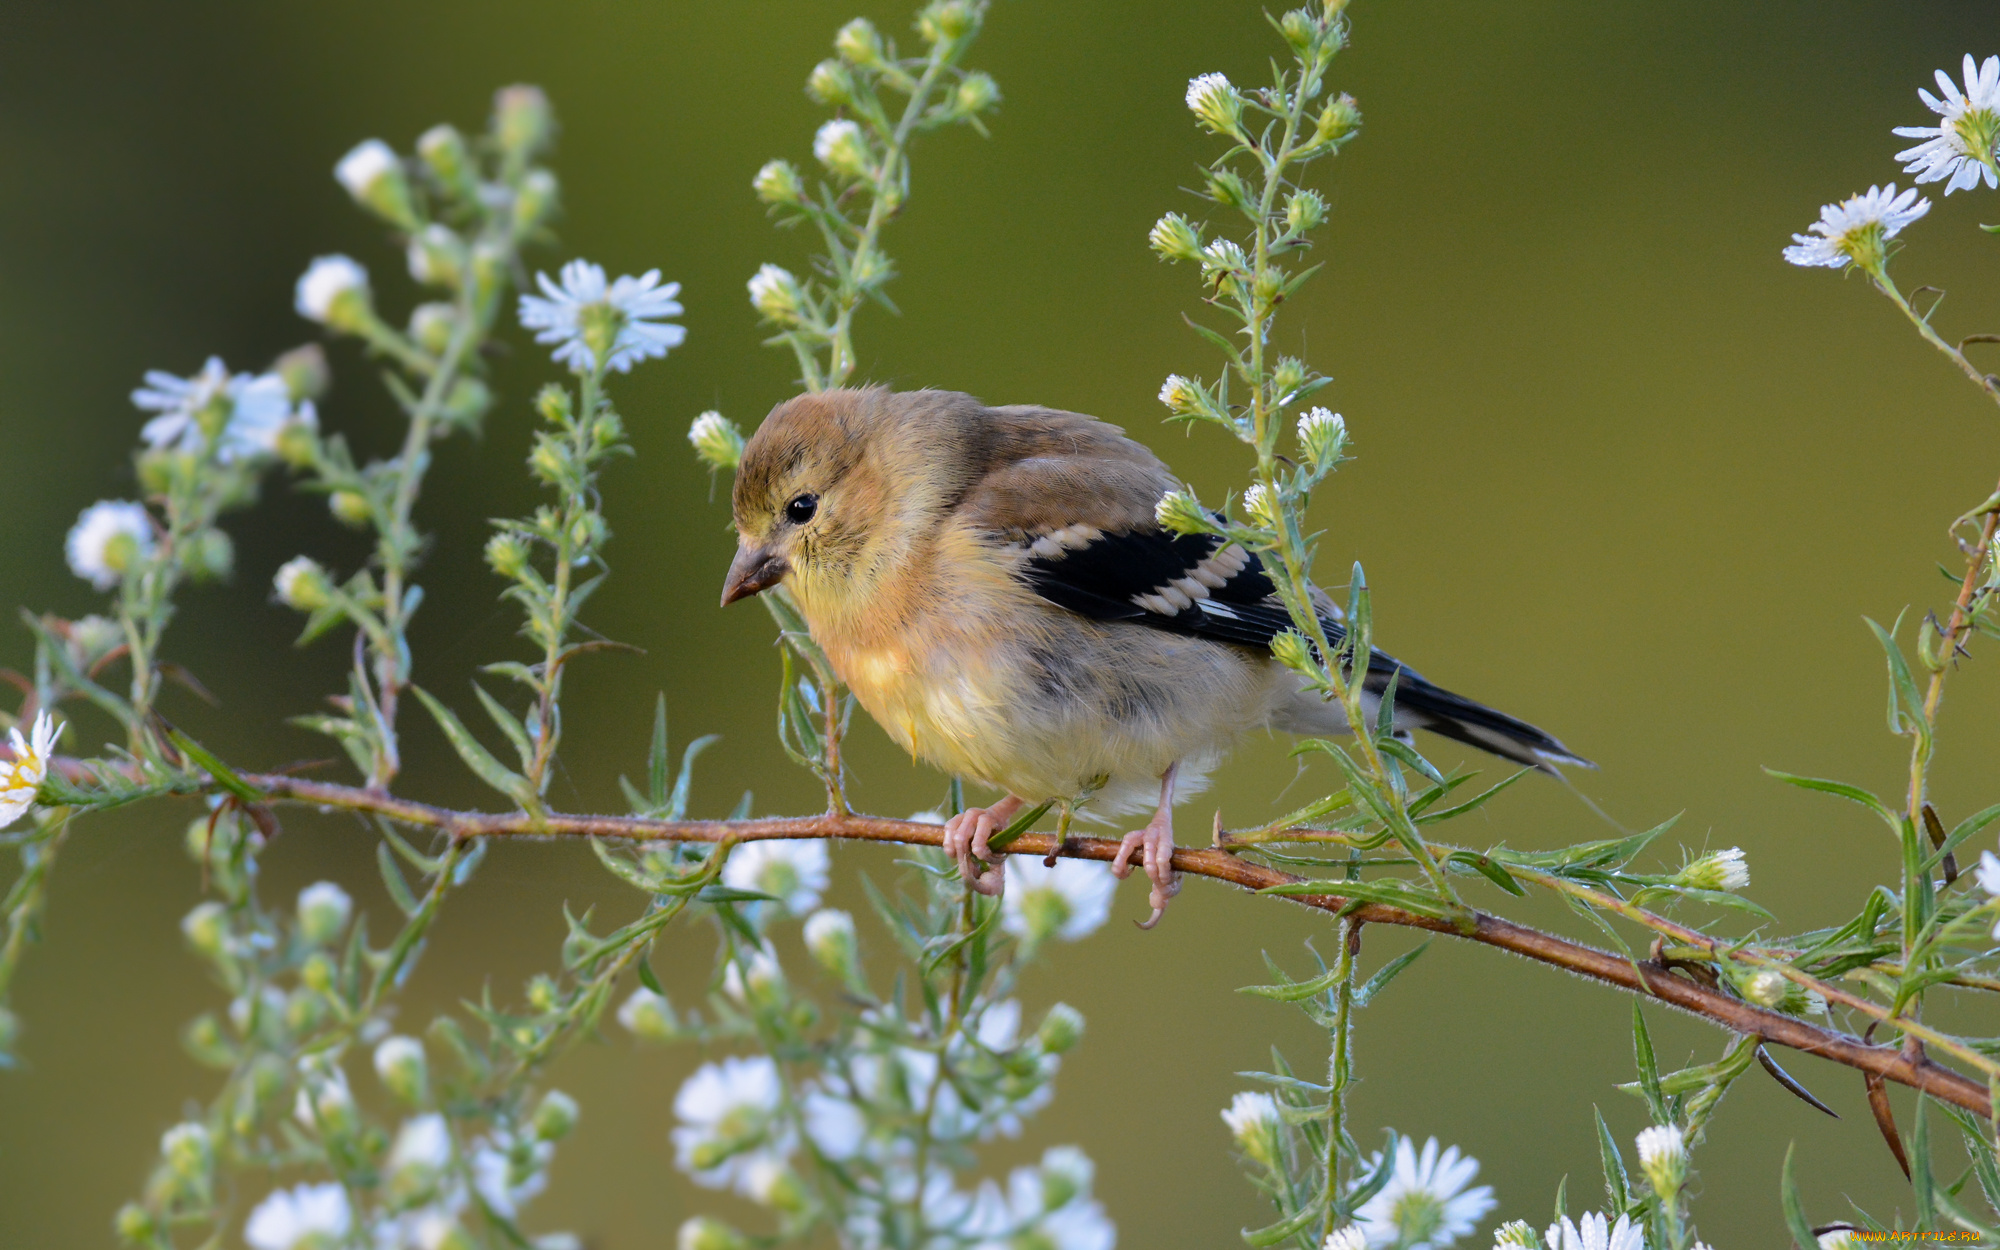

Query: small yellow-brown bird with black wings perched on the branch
[722,386,1590,928]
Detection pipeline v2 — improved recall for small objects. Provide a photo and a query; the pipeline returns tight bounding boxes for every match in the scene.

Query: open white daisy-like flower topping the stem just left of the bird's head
[520,260,688,374]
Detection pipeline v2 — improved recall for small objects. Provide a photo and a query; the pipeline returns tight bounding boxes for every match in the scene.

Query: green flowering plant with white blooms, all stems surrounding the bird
[0,0,2000,1250]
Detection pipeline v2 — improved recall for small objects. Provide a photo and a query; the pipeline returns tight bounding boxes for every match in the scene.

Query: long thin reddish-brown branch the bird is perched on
[215,774,1992,1118]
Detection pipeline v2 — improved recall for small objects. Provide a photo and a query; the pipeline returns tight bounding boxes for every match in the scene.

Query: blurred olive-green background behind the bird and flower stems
[0,0,2000,1248]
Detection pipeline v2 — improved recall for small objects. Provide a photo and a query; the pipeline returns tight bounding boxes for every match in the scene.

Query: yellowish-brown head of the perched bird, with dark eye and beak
[722,388,982,620]
